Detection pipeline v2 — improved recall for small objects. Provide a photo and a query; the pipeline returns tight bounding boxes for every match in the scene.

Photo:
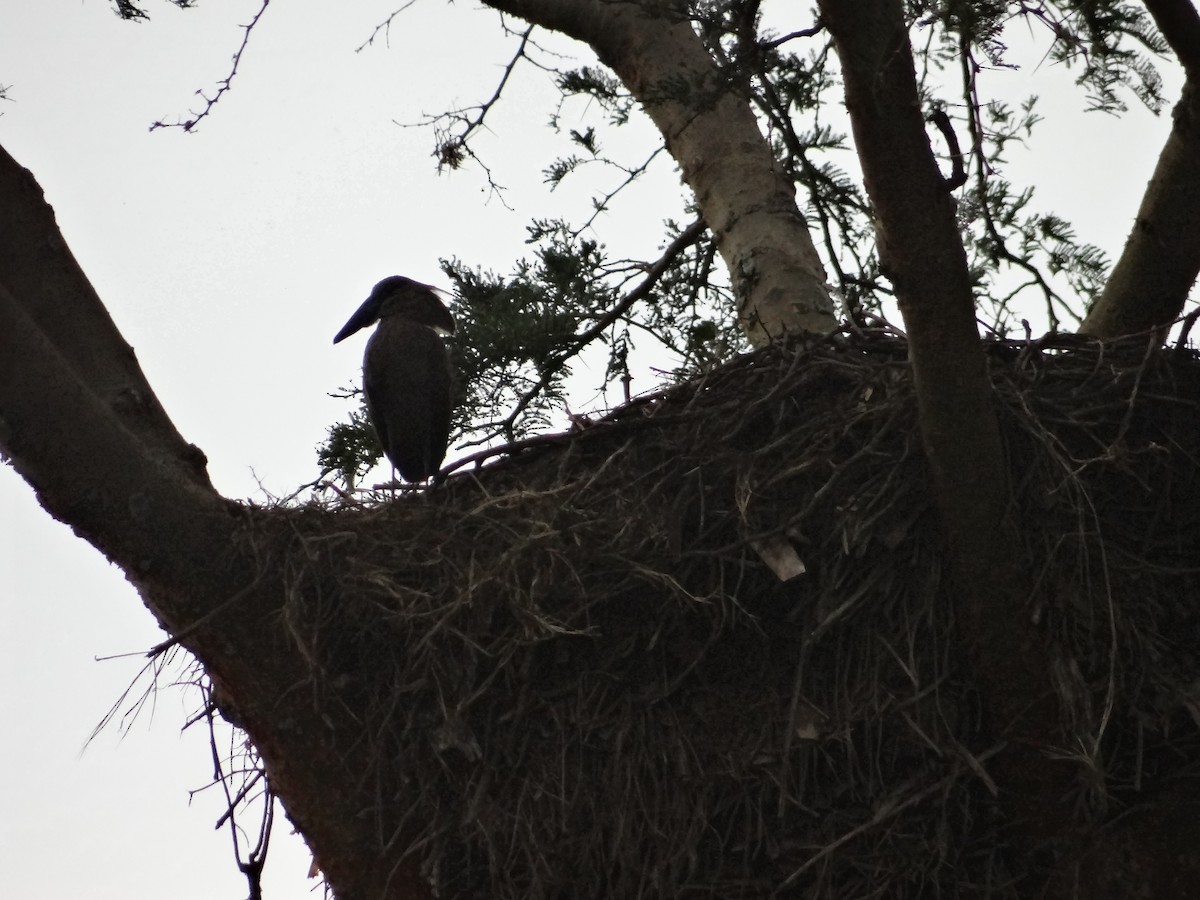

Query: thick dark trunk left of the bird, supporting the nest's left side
[0,150,430,900]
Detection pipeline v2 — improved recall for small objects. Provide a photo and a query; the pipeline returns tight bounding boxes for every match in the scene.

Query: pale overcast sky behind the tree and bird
[0,0,1175,900]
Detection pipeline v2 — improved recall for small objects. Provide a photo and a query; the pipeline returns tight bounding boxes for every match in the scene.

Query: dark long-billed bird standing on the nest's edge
[334,275,455,482]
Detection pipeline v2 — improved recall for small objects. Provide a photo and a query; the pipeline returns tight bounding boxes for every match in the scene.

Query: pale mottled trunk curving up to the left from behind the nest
[485,0,838,344]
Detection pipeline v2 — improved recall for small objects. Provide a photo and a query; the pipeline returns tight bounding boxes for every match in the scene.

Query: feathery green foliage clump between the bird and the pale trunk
[443,221,743,442]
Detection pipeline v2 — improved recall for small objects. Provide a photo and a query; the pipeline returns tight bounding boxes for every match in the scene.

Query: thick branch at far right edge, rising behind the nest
[1080,0,1200,338]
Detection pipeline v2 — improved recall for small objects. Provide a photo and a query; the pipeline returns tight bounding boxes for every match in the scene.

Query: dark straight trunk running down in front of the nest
[818,0,1070,868]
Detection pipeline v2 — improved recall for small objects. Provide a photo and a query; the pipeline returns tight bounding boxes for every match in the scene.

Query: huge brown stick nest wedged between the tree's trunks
[272,335,1200,899]
